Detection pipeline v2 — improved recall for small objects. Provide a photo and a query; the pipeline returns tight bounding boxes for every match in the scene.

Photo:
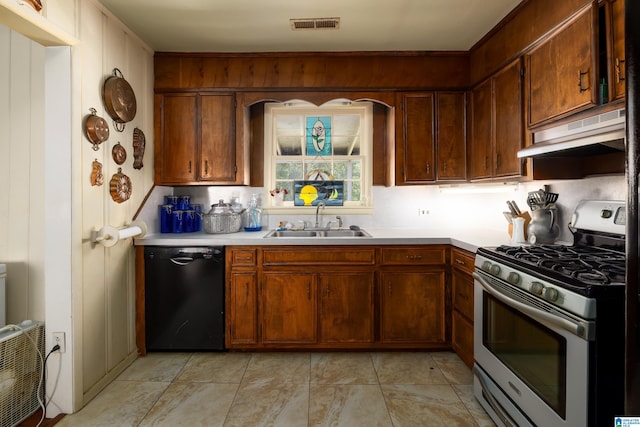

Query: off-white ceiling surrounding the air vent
[100,0,526,52]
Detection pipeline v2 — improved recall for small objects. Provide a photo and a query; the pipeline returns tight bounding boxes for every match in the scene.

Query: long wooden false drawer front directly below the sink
[262,246,376,266]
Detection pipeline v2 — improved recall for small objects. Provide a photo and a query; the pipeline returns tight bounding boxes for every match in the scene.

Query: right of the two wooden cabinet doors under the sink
[319,272,374,343]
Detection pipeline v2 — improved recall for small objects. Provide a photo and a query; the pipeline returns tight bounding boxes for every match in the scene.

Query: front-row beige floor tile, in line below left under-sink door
[224,382,309,427]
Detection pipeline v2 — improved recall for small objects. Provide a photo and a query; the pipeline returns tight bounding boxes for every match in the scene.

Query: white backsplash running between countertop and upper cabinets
[138,175,627,242]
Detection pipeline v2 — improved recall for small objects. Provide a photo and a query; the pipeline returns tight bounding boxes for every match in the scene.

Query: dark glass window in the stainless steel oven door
[482,293,567,419]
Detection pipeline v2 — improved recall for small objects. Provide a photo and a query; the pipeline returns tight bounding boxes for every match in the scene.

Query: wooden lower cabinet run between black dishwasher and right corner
[226,245,451,350]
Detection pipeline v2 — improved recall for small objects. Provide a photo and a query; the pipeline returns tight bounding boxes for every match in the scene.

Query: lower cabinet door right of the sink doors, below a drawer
[380,271,446,344]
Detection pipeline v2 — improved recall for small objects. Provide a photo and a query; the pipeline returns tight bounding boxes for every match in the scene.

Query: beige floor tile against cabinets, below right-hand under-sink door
[311,353,378,384]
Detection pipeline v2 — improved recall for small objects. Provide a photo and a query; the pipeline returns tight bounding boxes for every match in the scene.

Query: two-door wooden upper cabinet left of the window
[155,93,241,185]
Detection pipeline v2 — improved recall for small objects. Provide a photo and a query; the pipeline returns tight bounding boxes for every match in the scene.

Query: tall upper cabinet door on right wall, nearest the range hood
[492,60,524,177]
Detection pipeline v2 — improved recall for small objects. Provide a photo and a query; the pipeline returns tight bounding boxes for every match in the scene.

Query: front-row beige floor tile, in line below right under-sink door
[309,384,392,427]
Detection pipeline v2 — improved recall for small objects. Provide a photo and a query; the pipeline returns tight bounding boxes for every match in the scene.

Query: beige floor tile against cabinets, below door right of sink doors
[371,352,447,384]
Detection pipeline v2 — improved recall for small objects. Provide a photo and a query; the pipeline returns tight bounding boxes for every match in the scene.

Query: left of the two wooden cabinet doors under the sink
[261,272,317,344]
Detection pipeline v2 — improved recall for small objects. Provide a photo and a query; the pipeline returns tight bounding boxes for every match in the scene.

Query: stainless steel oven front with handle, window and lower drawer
[474,270,593,427]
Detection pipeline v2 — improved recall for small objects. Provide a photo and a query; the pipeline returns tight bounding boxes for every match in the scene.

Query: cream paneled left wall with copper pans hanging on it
[0,0,153,416]
